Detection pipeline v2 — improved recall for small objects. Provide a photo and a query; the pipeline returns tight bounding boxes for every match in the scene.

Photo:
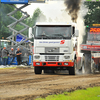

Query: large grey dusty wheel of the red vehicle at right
[82,54,91,74]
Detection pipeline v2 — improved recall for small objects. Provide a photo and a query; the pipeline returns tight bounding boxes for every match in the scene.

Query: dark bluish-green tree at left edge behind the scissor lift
[0,3,22,39]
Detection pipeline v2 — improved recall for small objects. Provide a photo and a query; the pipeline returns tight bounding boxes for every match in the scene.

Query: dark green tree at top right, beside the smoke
[84,2,100,27]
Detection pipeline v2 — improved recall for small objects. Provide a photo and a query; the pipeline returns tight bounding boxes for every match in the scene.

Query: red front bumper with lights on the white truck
[33,62,74,67]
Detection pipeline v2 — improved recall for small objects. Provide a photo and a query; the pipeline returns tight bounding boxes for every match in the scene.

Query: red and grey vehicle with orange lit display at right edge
[81,26,100,73]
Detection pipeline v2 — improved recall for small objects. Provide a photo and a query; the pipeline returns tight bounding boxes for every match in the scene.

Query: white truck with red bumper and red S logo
[33,22,79,75]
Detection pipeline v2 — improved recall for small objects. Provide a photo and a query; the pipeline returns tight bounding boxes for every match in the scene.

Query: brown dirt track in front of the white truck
[0,68,100,100]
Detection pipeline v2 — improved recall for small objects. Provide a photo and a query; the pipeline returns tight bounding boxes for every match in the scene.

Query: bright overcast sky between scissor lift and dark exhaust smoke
[17,1,72,19]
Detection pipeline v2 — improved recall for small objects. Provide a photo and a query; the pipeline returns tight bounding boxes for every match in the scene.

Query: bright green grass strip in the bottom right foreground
[35,87,100,100]
